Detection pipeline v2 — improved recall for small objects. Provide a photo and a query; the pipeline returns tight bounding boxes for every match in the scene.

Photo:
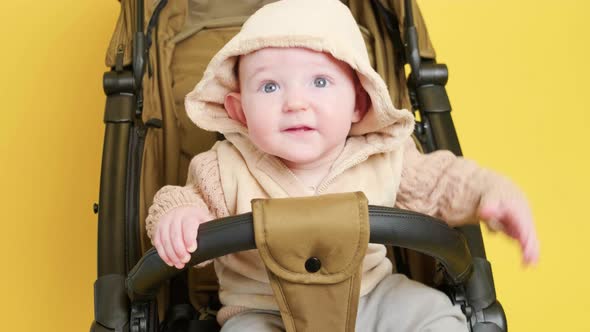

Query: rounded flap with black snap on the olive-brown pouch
[252,192,369,284]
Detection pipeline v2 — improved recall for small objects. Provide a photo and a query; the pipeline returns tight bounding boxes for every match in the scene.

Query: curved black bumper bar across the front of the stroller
[126,205,472,300]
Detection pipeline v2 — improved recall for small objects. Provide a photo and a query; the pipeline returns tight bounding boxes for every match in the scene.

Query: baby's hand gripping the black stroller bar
[152,206,213,269]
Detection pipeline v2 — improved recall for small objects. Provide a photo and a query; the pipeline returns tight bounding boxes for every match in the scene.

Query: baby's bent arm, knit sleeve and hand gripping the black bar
[146,151,228,269]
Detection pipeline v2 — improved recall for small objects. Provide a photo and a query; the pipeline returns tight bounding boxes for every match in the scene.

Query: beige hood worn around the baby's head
[185,0,414,152]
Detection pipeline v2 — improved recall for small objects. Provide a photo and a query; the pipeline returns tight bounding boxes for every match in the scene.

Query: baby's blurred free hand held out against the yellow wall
[478,186,539,264]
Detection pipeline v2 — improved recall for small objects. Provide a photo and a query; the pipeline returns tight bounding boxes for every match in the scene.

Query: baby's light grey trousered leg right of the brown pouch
[356,274,468,332]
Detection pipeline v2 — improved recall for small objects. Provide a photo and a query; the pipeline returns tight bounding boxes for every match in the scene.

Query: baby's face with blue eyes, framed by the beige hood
[229,48,364,168]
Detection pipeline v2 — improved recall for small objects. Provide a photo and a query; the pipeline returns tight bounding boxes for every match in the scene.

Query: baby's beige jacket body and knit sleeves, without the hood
[146,139,495,323]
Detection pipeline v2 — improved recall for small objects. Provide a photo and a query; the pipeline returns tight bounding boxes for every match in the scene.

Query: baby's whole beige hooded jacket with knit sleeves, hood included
[146,0,508,323]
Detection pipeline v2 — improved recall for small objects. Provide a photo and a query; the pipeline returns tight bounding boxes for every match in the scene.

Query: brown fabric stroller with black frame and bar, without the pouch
[91,0,507,332]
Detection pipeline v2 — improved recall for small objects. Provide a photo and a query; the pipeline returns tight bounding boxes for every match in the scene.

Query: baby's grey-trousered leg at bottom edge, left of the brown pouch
[221,309,285,332]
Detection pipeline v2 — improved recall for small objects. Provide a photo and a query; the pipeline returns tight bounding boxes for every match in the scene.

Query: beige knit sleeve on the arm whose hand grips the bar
[146,150,229,239]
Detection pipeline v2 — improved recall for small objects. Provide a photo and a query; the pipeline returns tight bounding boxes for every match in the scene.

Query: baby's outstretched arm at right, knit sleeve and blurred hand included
[396,140,539,264]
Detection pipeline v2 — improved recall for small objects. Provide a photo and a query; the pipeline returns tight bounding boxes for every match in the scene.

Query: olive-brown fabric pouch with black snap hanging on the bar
[252,192,369,332]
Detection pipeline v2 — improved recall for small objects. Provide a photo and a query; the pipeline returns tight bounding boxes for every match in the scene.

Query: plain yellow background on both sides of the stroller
[0,0,590,332]
